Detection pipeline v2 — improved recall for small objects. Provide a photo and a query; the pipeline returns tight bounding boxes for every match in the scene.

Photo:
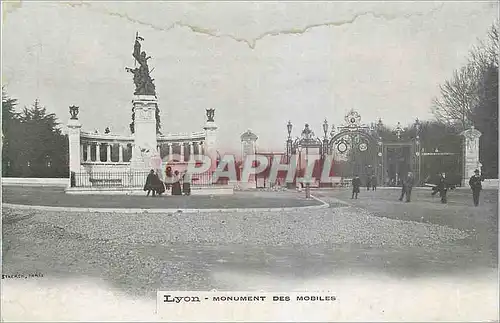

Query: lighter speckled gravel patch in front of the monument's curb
[3,207,468,247]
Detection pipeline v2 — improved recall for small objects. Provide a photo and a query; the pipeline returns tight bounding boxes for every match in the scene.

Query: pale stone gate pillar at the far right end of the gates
[461,126,482,186]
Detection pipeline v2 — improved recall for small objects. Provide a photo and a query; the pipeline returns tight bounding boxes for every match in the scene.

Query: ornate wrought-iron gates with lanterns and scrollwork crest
[286,110,421,186]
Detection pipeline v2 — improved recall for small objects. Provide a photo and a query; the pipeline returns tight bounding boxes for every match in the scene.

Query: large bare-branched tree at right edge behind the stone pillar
[433,21,499,178]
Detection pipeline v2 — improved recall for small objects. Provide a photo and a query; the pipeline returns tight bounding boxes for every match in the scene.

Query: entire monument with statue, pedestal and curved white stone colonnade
[67,34,225,194]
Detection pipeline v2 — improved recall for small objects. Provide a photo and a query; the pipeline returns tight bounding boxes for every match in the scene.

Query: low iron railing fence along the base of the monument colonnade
[71,171,228,188]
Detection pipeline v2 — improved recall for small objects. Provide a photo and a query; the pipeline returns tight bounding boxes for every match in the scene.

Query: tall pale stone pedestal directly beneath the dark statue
[130,95,158,170]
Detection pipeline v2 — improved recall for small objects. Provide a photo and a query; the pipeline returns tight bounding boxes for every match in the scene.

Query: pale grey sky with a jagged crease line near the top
[2,1,498,152]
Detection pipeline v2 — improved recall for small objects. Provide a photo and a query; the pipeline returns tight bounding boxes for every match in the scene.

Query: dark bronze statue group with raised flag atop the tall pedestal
[125,33,156,95]
